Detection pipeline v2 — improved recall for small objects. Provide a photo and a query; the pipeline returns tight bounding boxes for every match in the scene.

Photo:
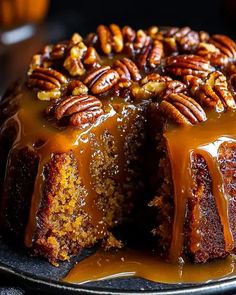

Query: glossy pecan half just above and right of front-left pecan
[84,66,119,94]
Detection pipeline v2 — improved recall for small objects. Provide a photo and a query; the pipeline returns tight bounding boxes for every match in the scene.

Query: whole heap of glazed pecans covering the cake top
[27,24,236,128]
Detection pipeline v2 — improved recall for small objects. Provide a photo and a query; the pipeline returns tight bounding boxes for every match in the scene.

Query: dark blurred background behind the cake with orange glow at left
[0,0,236,96]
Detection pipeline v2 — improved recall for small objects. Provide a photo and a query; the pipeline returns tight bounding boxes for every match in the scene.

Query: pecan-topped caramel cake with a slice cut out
[0,24,236,264]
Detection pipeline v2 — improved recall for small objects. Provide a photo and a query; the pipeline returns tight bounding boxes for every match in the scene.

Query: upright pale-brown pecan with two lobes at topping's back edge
[97,24,124,54]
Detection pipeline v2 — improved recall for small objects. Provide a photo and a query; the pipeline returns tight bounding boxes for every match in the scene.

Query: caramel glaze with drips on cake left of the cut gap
[0,89,147,247]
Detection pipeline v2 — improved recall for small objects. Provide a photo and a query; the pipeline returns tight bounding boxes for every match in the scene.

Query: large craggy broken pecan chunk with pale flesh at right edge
[196,71,236,112]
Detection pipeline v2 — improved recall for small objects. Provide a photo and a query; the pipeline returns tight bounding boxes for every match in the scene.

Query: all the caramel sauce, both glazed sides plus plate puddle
[3,84,236,283]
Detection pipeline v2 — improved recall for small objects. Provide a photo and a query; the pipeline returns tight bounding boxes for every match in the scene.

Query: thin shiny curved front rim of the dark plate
[0,262,236,295]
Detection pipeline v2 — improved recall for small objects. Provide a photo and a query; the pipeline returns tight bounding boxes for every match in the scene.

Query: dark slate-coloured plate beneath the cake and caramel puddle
[0,238,236,295]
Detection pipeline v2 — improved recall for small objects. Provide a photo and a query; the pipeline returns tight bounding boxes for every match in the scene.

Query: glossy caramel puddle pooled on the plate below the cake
[62,249,236,284]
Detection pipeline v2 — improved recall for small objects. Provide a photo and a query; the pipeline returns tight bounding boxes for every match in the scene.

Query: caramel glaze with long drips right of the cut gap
[164,111,236,261]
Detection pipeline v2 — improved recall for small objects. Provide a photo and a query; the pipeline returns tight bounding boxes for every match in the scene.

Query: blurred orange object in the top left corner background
[0,0,49,29]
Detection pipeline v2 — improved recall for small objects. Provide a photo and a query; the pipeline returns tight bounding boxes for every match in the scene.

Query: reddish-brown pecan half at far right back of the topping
[209,35,236,59]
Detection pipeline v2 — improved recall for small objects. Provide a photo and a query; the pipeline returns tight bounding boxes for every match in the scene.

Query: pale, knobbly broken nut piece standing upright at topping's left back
[63,42,87,76]
